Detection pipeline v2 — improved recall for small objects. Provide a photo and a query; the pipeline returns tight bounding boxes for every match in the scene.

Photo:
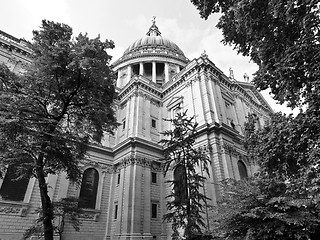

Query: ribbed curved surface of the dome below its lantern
[124,35,184,56]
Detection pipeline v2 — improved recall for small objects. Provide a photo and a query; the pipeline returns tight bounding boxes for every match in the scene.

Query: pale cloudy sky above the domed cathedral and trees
[0,0,292,114]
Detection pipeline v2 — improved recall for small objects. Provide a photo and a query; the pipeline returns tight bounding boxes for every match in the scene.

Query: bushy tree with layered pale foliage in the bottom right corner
[213,176,320,240]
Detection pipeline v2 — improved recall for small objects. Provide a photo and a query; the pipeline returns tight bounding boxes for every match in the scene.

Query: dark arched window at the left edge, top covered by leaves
[0,165,29,202]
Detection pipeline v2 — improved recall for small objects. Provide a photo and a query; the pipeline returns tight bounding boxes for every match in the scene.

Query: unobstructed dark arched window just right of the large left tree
[79,168,99,209]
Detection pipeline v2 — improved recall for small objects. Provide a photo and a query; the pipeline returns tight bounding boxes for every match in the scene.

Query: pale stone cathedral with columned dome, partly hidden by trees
[0,21,272,240]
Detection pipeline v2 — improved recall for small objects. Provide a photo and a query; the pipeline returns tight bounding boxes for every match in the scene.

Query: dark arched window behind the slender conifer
[173,165,188,205]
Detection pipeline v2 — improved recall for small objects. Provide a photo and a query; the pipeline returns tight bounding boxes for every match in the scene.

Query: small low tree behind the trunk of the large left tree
[23,198,83,240]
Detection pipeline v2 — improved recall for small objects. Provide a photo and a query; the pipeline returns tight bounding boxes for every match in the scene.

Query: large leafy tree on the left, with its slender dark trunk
[0,20,116,240]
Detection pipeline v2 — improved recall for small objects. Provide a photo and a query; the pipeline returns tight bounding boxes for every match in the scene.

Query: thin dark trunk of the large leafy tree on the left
[36,156,53,240]
